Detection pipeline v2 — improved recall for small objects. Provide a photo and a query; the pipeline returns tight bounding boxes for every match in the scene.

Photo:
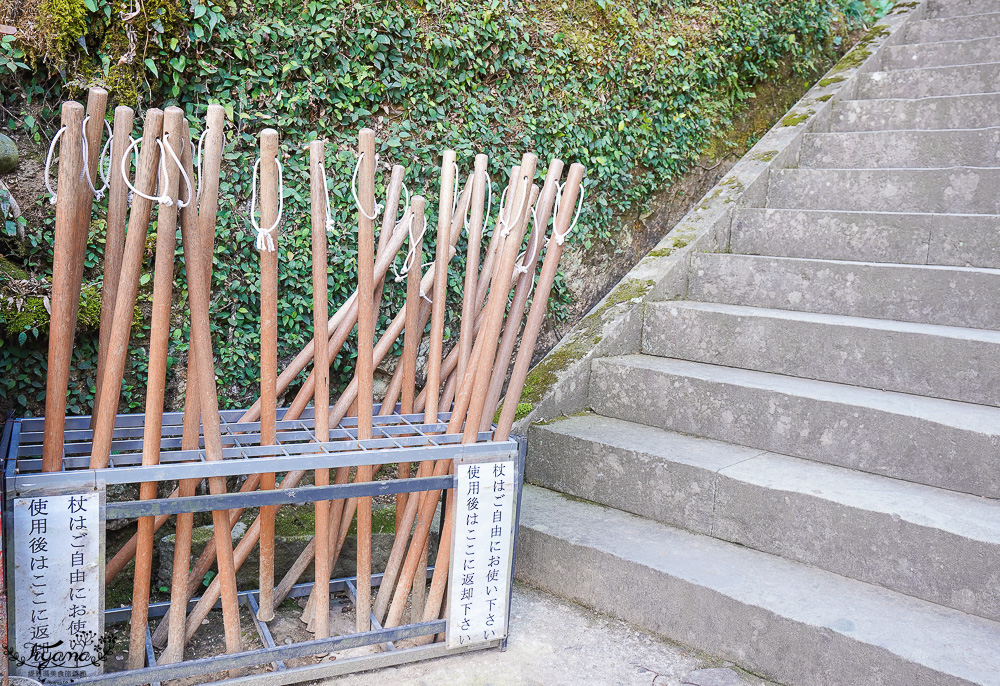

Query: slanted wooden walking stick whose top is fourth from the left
[90,108,163,469]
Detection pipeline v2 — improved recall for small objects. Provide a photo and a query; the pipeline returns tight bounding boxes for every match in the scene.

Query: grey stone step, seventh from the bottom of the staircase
[767,167,1000,214]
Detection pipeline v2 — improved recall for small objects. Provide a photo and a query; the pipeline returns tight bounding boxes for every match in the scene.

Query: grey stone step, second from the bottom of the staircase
[528,415,1000,621]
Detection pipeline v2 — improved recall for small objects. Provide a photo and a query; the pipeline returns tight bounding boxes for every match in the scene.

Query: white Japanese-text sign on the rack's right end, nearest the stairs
[447,460,517,648]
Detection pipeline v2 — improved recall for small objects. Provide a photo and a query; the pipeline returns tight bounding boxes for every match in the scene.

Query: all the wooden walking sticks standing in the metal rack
[43,89,584,668]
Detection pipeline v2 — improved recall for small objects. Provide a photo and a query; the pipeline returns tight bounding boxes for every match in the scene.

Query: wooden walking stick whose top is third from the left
[90,105,135,428]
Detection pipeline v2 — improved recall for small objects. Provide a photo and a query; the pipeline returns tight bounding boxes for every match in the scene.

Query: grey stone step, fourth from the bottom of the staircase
[642,301,1000,405]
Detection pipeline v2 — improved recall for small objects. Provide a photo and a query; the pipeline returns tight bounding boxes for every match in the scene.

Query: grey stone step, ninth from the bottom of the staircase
[830,93,1000,131]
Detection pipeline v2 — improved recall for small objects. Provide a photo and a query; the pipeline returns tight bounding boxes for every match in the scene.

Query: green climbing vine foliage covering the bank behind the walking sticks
[0,0,885,412]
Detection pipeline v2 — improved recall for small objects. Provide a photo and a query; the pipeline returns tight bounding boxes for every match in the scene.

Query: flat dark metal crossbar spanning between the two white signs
[106,476,454,519]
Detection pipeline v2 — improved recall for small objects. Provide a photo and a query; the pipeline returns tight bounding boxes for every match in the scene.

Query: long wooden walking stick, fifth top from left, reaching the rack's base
[128,107,187,669]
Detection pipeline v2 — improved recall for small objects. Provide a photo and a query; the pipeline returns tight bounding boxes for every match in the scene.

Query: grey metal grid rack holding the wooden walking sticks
[0,405,525,686]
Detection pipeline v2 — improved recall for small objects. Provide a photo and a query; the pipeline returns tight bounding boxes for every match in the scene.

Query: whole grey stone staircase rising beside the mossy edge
[518,0,1000,686]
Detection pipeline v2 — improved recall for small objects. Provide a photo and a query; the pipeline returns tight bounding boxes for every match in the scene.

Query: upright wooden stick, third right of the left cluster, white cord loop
[354,129,376,632]
